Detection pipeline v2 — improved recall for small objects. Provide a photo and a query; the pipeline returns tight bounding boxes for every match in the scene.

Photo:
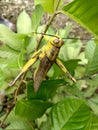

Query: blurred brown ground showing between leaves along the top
[0,0,91,38]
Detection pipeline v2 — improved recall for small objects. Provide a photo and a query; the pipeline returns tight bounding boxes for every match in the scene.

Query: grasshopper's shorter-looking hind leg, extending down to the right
[55,59,76,82]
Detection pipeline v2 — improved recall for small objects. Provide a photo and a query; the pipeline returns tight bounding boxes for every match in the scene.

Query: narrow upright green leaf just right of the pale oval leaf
[32,5,43,31]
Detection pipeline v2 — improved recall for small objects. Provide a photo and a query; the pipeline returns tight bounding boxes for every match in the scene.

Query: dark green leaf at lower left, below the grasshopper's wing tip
[15,100,53,119]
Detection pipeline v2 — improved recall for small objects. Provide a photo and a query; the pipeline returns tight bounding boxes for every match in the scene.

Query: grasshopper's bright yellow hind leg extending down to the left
[10,50,40,86]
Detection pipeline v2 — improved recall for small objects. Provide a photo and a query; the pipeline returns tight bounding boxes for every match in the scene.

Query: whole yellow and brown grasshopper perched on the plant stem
[10,36,76,92]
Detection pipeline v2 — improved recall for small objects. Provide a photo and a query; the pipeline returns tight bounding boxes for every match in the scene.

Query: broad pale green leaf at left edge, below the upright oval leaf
[0,24,25,50]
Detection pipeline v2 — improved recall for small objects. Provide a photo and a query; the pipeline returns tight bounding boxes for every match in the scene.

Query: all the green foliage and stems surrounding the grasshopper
[0,0,98,130]
